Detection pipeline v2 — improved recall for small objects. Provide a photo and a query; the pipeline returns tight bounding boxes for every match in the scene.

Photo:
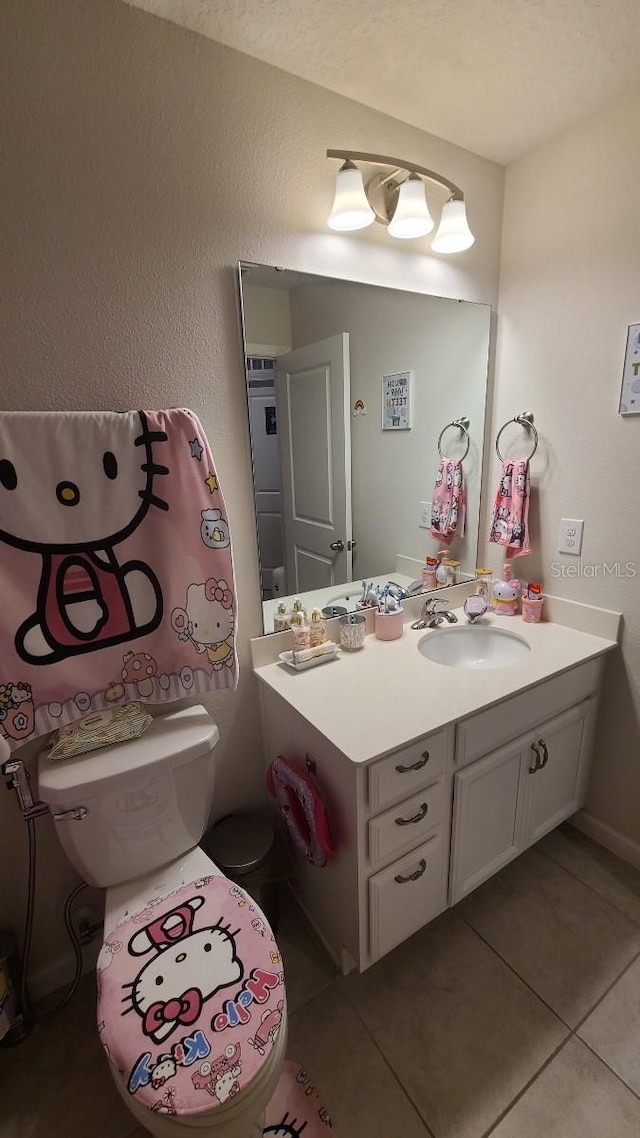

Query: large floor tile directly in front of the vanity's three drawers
[347,913,567,1138]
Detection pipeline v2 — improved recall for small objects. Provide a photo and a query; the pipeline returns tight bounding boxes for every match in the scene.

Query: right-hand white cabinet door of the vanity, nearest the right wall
[526,700,596,846]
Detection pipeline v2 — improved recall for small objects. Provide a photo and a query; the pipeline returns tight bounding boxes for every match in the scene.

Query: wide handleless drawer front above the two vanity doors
[456,660,601,767]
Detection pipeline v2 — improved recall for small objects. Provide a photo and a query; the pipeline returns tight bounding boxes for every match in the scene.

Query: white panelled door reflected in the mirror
[276,332,352,593]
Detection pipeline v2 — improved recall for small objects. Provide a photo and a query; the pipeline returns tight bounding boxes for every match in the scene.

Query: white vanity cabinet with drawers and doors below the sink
[259,643,601,971]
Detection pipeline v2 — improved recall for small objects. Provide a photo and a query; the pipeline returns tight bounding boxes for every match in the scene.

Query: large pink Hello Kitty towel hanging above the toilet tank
[0,410,238,748]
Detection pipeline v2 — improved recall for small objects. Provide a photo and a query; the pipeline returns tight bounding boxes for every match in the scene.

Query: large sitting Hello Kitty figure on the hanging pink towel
[0,411,169,665]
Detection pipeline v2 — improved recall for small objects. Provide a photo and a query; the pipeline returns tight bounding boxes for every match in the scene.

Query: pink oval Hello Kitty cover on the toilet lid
[97,875,285,1114]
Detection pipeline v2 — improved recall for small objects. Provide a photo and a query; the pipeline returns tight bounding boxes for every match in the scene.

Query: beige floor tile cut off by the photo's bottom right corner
[491,1038,640,1138]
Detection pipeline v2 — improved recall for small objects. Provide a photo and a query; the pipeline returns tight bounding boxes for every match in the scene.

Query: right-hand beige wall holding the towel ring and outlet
[485,88,640,854]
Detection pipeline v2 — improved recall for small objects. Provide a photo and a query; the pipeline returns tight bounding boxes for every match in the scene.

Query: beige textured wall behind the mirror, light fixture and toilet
[0,0,503,987]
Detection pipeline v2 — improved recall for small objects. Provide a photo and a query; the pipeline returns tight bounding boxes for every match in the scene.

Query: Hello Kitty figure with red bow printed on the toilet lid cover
[122,897,244,1044]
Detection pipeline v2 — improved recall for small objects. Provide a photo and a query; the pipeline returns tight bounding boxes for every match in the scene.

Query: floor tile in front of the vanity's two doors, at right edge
[457,850,640,1026]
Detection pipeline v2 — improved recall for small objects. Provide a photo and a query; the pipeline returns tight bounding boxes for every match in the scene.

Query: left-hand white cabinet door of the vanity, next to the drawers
[451,735,532,905]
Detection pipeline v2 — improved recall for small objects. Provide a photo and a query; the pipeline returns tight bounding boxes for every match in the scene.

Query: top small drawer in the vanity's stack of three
[369,731,450,810]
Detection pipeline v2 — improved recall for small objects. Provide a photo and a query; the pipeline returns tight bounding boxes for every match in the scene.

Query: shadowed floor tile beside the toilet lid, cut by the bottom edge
[287,981,428,1138]
